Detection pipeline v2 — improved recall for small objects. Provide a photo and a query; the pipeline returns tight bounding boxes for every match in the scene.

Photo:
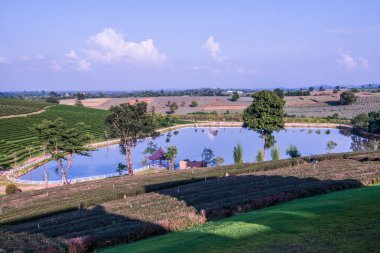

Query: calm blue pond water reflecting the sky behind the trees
[20,127,363,181]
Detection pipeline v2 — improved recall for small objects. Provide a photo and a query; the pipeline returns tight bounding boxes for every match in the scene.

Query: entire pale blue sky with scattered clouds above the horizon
[0,0,380,91]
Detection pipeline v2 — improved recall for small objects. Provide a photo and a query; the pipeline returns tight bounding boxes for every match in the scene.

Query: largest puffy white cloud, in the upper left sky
[86,28,167,64]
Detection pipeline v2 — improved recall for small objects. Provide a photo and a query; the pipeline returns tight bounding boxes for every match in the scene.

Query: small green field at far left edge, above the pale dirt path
[0,98,52,117]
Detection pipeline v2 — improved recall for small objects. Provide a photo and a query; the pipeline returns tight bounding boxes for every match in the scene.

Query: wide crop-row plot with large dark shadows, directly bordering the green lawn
[0,159,380,252]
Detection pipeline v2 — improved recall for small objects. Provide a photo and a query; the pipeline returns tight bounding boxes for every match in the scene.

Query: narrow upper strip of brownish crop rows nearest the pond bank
[0,150,378,224]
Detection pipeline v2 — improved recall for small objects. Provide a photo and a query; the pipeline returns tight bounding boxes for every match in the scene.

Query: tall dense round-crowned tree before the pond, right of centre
[243,90,285,161]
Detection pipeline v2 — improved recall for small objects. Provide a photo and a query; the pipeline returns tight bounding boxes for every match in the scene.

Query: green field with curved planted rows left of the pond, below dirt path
[0,105,108,167]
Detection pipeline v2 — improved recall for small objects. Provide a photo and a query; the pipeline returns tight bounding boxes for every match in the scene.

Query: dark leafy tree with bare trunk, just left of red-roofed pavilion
[105,102,156,175]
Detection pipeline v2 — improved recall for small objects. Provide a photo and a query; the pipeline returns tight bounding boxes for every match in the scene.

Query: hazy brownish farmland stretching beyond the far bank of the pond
[61,91,380,119]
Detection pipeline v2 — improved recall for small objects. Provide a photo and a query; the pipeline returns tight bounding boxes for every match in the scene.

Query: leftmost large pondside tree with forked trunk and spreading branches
[34,118,91,185]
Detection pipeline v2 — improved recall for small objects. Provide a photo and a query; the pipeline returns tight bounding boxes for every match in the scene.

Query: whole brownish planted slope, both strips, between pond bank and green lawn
[0,153,380,252]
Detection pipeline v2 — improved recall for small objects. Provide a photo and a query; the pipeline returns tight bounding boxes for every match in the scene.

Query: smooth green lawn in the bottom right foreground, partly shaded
[103,185,380,253]
